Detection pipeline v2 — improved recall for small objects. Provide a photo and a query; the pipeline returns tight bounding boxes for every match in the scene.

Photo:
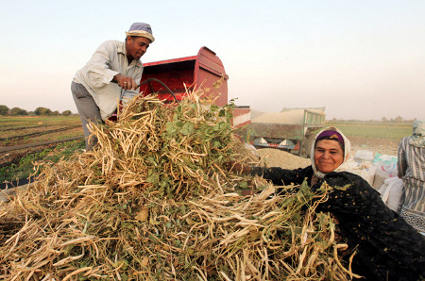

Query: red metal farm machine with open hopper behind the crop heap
[140,47,251,127]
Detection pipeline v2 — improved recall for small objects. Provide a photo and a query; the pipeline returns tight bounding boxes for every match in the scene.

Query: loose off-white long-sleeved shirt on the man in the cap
[73,40,143,120]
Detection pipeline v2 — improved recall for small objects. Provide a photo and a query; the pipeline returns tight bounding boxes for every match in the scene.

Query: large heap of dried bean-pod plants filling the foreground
[0,91,351,281]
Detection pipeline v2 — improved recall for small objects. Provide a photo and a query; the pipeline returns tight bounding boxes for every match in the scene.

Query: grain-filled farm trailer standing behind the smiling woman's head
[249,108,325,156]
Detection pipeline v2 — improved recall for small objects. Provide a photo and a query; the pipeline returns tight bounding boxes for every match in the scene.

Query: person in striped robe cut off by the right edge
[397,120,425,235]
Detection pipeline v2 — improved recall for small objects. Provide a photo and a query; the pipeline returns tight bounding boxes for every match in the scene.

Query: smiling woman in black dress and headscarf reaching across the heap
[251,127,425,280]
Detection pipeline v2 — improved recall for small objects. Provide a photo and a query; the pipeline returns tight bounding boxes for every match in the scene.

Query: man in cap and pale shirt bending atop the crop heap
[71,22,155,150]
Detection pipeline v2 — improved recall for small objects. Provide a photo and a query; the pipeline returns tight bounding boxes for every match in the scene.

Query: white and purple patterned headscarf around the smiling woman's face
[310,127,351,178]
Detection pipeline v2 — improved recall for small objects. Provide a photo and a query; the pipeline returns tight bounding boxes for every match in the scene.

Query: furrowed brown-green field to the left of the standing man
[0,115,84,188]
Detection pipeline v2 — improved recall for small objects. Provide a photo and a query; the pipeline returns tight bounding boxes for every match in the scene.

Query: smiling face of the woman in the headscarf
[314,139,344,173]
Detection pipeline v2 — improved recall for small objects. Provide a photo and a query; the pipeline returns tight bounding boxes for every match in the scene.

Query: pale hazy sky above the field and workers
[0,0,425,120]
